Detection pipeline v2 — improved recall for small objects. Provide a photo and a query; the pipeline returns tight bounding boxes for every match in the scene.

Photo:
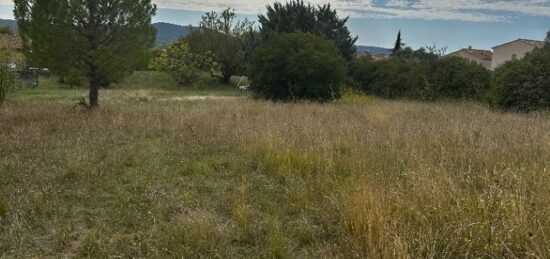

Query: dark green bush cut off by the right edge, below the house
[491,48,550,111]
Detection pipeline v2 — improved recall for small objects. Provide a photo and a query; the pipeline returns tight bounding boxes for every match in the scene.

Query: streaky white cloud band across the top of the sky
[154,0,550,22]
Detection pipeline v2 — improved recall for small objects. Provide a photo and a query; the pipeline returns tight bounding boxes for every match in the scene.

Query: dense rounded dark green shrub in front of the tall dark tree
[250,32,347,101]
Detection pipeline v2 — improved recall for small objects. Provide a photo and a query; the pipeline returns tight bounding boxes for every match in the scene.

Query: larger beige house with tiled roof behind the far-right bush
[491,39,544,69]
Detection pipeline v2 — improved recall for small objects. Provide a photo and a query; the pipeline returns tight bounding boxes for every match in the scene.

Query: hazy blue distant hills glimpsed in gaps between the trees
[0,19,391,55]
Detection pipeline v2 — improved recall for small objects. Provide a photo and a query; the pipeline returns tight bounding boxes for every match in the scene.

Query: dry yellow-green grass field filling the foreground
[0,76,550,258]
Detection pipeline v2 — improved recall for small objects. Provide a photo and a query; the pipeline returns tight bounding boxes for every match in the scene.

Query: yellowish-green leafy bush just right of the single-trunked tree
[150,40,217,86]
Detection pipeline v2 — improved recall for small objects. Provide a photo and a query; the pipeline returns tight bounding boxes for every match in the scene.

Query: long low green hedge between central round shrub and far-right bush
[358,47,491,100]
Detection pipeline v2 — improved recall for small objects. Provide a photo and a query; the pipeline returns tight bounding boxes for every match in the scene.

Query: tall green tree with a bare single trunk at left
[14,0,156,108]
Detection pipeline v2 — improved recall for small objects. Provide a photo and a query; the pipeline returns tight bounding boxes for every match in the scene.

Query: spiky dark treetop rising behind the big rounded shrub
[258,0,357,62]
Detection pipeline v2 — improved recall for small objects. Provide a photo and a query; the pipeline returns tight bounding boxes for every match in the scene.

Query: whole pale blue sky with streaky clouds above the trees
[0,0,550,52]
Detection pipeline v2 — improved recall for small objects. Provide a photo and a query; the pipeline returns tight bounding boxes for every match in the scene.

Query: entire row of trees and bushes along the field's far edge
[1,0,550,110]
